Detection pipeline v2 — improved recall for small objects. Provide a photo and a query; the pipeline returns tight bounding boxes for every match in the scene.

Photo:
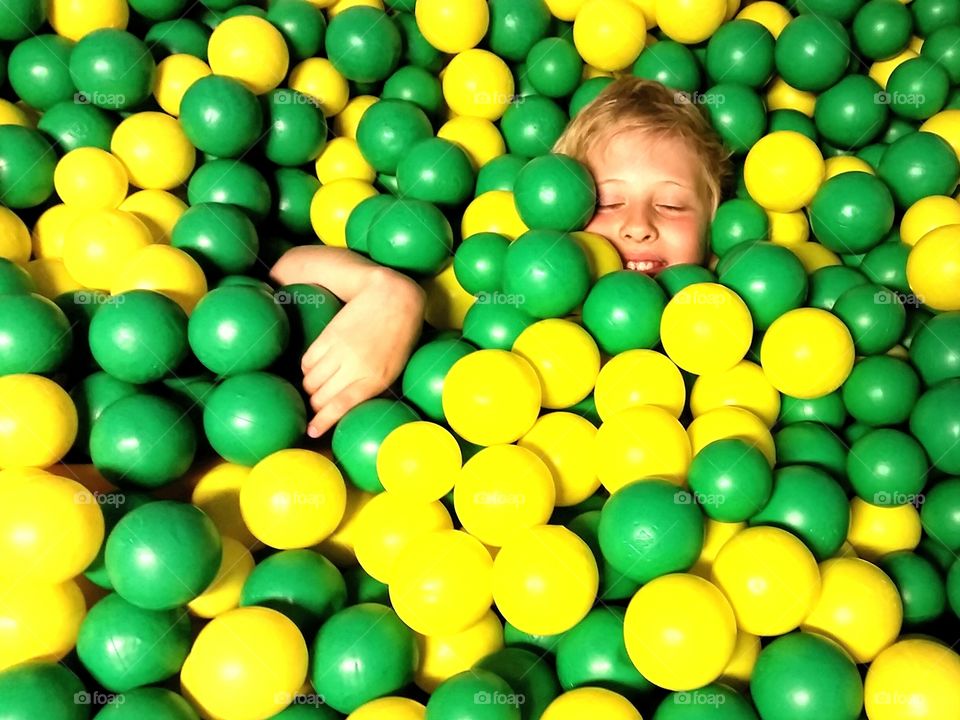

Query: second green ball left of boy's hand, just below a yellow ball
[89,290,189,385]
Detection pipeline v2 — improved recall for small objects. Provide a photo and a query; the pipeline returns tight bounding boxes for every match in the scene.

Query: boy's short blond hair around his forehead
[553,77,732,211]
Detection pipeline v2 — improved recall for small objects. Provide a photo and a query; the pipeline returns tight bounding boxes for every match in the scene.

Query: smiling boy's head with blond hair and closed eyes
[553,77,730,275]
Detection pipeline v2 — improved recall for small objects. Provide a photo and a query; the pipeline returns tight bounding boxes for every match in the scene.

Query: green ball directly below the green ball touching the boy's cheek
[503,230,590,318]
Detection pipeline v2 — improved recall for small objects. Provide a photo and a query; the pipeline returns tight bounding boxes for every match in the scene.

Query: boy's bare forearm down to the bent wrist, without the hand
[270,245,396,302]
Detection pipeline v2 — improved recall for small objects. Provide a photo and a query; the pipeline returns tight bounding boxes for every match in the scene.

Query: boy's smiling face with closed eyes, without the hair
[586,130,710,275]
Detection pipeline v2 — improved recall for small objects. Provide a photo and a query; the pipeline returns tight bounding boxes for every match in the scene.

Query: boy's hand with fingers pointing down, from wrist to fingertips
[301,268,425,437]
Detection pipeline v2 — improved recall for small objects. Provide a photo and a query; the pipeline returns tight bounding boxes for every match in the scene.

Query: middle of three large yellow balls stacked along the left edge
[0,470,104,583]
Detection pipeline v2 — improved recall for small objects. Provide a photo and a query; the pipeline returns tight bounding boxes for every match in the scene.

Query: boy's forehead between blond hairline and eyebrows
[586,128,701,187]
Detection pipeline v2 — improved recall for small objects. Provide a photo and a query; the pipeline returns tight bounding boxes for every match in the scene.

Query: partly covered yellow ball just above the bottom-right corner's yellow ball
[802,558,903,663]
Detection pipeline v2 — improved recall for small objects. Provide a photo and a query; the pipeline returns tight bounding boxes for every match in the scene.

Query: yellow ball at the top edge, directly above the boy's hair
[573,0,648,71]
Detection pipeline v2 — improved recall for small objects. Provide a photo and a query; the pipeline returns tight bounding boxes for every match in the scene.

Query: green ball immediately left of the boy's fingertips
[203,372,307,465]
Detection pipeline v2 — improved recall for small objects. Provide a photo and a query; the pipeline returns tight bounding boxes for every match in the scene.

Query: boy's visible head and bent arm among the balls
[270,77,730,437]
